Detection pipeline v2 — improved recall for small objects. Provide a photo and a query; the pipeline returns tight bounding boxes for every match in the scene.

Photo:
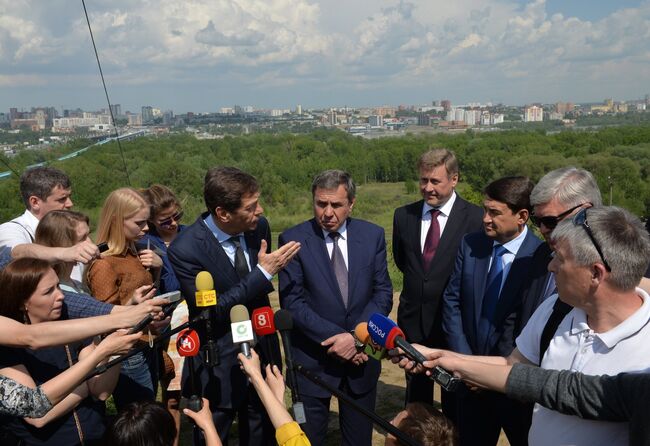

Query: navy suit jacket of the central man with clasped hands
[279,219,393,398]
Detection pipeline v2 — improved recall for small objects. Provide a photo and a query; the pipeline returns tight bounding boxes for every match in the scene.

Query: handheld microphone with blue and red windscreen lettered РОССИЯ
[368,313,460,392]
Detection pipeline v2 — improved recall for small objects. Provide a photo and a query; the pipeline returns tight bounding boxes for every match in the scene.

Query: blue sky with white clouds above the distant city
[0,0,650,114]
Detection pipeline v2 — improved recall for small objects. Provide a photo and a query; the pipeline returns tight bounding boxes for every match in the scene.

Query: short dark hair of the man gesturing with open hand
[203,167,259,214]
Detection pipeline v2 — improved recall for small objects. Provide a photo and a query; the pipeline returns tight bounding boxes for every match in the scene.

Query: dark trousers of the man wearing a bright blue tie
[456,388,532,446]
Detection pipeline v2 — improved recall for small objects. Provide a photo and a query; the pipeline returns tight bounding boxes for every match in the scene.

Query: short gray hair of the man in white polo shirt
[551,206,650,291]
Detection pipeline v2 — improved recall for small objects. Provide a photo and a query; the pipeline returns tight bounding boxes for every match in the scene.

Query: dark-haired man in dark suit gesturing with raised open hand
[168,167,300,445]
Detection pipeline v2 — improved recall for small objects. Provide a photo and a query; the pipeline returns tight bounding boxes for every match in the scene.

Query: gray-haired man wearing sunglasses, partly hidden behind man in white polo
[515,167,602,337]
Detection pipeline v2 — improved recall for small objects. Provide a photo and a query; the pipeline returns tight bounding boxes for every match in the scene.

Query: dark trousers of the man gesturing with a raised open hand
[193,385,276,446]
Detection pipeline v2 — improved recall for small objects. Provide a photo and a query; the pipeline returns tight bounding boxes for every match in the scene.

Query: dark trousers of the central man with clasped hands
[300,379,377,446]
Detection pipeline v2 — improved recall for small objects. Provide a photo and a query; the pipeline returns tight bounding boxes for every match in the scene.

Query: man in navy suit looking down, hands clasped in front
[279,170,393,446]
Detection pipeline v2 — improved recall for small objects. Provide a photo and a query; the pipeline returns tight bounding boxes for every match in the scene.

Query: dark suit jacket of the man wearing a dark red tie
[393,196,483,347]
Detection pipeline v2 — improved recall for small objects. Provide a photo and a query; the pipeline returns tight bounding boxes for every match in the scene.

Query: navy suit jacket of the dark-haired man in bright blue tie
[442,231,541,356]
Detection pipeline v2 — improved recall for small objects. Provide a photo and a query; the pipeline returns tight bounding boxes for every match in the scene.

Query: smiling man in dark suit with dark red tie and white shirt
[393,149,483,410]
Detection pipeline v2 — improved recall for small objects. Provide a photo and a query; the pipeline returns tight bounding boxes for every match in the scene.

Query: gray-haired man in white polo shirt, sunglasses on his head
[400,207,650,446]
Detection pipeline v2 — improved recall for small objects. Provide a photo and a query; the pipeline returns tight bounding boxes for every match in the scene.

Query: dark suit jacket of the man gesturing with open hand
[167,213,280,408]
